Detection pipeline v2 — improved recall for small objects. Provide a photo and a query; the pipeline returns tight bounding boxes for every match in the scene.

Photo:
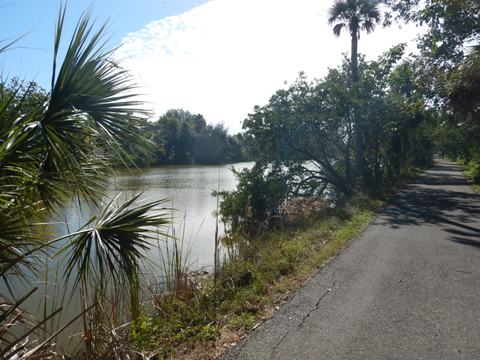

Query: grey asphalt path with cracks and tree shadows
[223,161,480,360]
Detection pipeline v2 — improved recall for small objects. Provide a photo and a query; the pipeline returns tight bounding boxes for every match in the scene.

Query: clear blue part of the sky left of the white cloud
[0,0,207,88]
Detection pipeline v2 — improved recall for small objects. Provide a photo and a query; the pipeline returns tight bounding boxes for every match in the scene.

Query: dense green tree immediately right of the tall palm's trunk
[359,44,434,186]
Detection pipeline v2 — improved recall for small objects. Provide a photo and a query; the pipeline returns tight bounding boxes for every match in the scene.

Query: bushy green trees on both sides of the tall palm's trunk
[222,45,435,232]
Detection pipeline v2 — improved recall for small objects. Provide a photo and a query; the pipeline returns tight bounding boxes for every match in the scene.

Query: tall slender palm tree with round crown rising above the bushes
[328,0,380,191]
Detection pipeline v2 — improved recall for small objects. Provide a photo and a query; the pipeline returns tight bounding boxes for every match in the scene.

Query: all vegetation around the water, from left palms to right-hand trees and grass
[0,0,480,360]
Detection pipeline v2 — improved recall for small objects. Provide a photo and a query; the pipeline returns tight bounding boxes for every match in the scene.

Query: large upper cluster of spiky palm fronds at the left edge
[0,7,149,208]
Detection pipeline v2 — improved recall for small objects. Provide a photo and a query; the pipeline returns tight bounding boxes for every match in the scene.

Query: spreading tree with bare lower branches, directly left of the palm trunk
[243,69,353,196]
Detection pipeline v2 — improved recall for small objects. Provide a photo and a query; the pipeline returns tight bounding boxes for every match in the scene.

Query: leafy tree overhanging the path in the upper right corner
[384,0,480,162]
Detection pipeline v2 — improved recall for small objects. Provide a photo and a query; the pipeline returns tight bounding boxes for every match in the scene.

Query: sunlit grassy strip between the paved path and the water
[132,199,381,359]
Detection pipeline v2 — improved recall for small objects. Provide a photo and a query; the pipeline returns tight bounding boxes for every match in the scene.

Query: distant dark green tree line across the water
[0,78,251,167]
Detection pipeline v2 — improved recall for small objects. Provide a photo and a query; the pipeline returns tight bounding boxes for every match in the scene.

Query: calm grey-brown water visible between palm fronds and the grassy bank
[0,163,253,349]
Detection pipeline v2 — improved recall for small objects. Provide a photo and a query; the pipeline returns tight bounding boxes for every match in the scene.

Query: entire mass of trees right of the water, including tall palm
[222,0,480,233]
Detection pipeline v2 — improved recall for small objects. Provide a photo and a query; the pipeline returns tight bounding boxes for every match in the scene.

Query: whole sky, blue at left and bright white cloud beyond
[0,0,420,133]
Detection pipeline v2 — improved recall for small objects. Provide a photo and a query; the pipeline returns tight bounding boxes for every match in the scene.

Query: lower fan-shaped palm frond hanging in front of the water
[58,195,169,292]
